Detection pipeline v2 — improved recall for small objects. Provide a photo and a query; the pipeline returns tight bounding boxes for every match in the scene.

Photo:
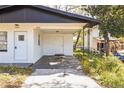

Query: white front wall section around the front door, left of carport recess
[0,25,33,63]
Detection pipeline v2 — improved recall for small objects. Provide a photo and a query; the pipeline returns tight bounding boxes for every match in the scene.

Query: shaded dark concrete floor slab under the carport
[32,56,80,70]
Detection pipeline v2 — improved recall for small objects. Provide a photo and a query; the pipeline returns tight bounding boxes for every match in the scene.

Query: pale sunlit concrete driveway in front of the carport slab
[22,69,100,88]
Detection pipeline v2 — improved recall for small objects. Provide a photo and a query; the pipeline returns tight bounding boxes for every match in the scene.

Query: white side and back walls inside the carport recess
[33,32,73,63]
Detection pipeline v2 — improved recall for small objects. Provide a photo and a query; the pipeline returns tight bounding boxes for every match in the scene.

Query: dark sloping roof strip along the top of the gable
[0,5,100,25]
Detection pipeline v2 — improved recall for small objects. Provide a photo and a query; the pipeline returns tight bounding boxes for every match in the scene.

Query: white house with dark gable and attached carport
[0,5,99,65]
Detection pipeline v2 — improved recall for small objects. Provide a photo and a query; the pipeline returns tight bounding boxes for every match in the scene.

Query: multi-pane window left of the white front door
[0,32,7,51]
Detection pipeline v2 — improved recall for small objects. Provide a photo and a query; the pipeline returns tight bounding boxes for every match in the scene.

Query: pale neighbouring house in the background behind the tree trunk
[84,25,120,52]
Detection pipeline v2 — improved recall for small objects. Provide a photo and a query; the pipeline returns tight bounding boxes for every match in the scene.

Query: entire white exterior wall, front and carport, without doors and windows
[0,29,73,63]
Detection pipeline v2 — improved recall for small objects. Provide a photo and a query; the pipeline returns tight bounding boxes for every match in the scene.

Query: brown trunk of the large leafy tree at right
[103,32,110,56]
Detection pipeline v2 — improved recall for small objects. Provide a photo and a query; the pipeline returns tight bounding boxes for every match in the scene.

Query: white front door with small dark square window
[14,32,27,60]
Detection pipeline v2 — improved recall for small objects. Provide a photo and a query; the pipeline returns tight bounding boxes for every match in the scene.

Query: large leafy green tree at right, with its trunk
[85,5,124,56]
